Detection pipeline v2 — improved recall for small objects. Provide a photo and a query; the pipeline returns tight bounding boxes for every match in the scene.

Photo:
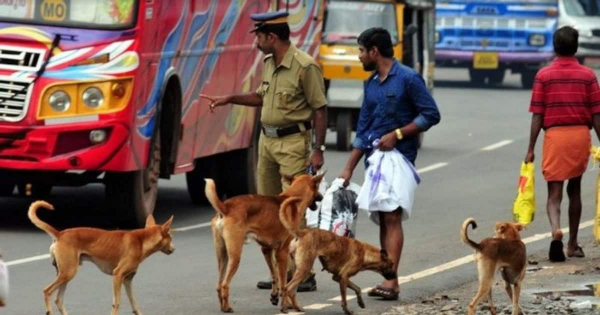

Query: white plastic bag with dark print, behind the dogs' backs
[308,178,360,237]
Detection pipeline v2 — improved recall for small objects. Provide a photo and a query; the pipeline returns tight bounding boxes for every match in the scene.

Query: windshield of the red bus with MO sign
[0,0,137,29]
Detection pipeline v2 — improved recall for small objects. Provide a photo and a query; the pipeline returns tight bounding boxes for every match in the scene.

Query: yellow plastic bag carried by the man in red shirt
[513,162,536,225]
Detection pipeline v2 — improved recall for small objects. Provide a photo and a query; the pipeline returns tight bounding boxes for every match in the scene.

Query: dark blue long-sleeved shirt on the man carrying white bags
[352,61,440,164]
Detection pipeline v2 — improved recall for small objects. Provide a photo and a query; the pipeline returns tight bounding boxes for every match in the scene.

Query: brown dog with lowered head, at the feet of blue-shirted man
[279,198,398,314]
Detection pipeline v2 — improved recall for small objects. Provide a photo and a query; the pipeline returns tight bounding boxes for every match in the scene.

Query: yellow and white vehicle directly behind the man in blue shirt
[318,0,435,151]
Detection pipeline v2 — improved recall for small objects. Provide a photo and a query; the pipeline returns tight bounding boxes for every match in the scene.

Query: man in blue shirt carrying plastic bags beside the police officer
[340,28,440,300]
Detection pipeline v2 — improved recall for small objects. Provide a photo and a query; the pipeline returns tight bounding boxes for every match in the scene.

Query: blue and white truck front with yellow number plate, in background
[435,0,558,88]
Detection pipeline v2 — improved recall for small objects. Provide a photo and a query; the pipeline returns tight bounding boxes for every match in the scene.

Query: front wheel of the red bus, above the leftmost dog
[105,130,160,228]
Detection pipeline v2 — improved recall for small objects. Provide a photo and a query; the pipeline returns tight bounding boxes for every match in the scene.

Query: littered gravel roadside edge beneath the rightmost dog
[381,238,600,315]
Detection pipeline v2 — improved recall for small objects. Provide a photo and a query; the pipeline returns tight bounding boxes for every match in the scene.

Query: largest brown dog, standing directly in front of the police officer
[205,173,325,313]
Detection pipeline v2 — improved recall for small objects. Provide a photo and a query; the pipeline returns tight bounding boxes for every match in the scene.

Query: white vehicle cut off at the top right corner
[558,0,600,61]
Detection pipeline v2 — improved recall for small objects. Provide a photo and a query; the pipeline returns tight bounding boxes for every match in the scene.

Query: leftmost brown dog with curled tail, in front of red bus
[28,201,175,315]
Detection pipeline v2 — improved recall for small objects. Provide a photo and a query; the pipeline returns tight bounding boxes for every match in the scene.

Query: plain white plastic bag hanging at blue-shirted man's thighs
[357,149,421,225]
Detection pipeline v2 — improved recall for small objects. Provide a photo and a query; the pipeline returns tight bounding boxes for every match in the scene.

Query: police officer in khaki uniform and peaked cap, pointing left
[200,11,327,291]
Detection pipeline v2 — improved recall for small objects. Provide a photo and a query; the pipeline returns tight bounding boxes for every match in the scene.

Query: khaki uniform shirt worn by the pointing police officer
[256,45,327,127]
